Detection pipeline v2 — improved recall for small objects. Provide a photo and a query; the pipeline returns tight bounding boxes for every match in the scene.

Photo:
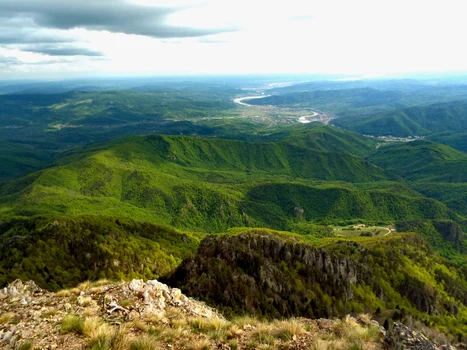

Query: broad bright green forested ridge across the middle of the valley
[0,131,451,231]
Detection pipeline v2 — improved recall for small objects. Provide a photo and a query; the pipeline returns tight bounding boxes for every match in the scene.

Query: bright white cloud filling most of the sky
[0,0,467,75]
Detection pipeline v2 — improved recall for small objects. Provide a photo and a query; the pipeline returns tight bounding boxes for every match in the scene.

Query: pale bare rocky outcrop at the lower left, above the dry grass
[0,280,223,350]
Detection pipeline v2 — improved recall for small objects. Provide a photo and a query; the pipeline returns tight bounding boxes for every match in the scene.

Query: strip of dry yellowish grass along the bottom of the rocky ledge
[55,300,381,350]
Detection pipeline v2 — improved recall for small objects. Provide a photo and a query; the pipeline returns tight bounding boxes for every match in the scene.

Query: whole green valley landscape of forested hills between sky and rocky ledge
[0,79,467,342]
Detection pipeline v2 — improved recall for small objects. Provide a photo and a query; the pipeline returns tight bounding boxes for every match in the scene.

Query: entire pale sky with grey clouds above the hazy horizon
[0,0,467,79]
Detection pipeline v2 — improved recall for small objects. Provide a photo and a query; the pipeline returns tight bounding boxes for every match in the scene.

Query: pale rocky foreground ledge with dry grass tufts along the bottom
[0,280,455,350]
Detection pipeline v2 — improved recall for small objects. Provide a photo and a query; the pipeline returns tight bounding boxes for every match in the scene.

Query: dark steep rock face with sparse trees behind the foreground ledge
[169,233,363,317]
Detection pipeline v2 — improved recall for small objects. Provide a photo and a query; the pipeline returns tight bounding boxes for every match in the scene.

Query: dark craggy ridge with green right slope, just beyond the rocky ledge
[168,230,467,339]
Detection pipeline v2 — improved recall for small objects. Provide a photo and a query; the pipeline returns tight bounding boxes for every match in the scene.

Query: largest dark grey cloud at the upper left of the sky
[0,0,233,41]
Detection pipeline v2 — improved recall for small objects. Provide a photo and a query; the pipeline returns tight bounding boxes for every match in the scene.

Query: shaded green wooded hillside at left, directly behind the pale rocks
[0,216,200,290]
